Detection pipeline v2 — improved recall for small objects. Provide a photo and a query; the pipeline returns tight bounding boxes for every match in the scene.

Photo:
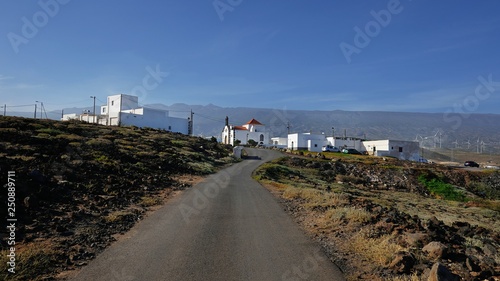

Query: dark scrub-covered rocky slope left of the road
[0,116,233,280]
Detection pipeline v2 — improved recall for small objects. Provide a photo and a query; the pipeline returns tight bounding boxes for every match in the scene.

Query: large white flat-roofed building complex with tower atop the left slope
[62,95,190,135]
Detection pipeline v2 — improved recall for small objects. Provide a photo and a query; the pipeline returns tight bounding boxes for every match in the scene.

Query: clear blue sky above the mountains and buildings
[0,0,500,114]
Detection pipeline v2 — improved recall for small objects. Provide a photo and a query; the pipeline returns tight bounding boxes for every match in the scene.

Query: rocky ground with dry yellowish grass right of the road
[254,153,500,281]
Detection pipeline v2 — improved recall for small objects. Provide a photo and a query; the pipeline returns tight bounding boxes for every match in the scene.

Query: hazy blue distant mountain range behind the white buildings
[4,103,500,153]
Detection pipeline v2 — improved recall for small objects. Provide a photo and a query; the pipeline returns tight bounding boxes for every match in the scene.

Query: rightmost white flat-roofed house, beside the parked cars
[363,140,420,161]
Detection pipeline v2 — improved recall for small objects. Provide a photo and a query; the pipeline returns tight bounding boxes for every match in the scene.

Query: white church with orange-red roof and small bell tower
[222,117,269,145]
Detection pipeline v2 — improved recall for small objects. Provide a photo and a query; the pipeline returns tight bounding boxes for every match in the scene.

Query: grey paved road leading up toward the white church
[74,150,345,281]
